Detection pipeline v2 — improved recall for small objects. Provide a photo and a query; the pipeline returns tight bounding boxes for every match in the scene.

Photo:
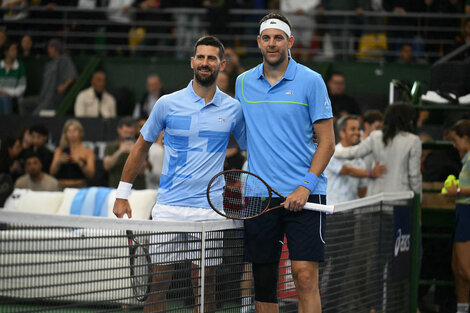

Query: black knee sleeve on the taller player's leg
[253,263,279,303]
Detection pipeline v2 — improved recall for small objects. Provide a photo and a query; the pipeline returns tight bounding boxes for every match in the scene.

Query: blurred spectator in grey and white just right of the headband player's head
[279,0,320,61]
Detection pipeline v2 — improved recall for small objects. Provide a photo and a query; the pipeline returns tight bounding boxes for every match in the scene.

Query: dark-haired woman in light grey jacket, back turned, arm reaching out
[334,104,422,196]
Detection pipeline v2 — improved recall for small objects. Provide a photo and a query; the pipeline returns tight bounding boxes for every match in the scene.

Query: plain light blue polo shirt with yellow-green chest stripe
[235,58,333,196]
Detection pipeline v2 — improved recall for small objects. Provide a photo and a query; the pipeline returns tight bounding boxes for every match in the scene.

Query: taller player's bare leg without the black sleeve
[291,261,321,313]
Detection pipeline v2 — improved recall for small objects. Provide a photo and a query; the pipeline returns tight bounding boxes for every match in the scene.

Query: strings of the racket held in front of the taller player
[213,171,269,219]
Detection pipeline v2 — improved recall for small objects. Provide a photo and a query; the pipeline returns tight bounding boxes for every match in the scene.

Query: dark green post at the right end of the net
[410,193,421,313]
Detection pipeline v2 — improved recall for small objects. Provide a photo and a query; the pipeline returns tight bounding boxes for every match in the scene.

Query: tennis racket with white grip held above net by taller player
[207,170,334,220]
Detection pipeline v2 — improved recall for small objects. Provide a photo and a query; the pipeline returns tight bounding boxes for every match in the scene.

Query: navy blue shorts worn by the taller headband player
[244,195,326,264]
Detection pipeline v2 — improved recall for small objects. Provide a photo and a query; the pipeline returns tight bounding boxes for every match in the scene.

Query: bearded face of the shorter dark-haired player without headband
[191,45,225,87]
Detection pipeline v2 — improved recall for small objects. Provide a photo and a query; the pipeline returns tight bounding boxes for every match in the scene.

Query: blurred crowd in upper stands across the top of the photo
[0,0,470,62]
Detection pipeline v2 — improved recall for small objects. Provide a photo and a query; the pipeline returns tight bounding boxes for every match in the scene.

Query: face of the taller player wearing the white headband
[258,28,294,67]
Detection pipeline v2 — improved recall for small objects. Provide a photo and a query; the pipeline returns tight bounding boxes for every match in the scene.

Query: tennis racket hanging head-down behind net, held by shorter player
[126,230,152,301]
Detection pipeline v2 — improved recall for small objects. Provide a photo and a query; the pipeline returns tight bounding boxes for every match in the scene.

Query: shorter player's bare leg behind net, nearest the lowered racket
[144,264,175,313]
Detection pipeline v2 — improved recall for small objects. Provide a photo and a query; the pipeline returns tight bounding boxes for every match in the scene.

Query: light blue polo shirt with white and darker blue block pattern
[140,81,246,209]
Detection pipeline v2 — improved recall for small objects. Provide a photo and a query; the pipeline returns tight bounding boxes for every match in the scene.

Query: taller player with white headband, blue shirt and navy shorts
[235,13,335,313]
